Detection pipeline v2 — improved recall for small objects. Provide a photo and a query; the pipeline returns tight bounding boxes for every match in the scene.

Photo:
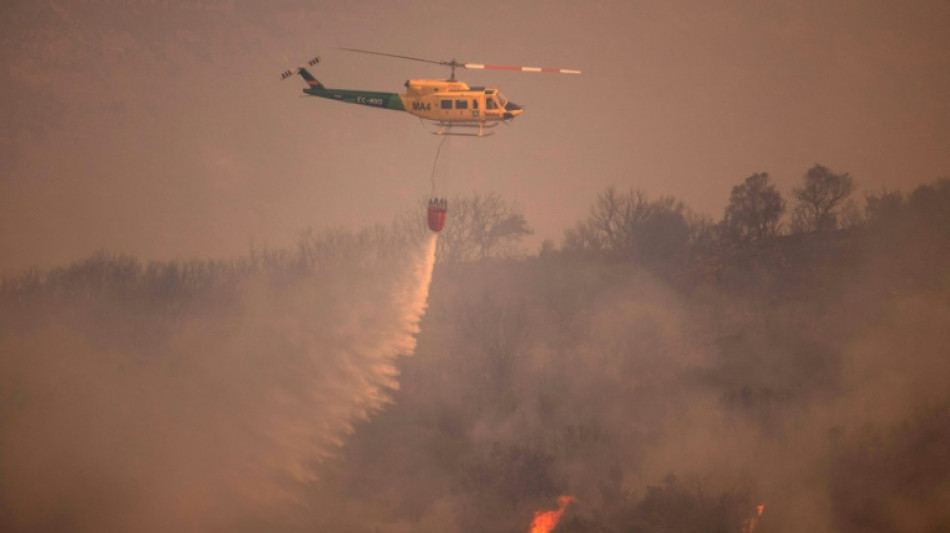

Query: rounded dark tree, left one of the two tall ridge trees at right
[723,172,785,244]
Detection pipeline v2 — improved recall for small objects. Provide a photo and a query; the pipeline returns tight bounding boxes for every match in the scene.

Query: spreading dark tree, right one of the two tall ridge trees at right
[792,164,854,233]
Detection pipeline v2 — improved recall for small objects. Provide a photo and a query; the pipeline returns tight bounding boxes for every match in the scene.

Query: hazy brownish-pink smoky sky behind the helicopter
[0,0,950,274]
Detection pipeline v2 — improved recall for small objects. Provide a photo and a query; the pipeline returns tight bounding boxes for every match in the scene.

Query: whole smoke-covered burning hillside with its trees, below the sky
[0,172,950,533]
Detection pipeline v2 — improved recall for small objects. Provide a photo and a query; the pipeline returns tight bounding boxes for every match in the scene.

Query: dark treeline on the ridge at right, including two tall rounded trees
[560,165,950,290]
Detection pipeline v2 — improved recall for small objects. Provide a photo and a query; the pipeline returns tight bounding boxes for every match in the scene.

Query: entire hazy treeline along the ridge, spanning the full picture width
[0,165,950,307]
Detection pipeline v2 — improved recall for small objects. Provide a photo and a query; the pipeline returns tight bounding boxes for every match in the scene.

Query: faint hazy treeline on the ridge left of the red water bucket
[0,222,416,332]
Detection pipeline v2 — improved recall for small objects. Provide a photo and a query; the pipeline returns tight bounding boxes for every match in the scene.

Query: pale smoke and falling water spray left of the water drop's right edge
[0,234,436,531]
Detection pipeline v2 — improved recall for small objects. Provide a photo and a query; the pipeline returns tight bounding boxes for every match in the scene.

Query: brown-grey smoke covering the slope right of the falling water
[310,217,950,532]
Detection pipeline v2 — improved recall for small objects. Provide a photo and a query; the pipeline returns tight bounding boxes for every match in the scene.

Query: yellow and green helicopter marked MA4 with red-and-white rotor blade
[281,48,581,137]
